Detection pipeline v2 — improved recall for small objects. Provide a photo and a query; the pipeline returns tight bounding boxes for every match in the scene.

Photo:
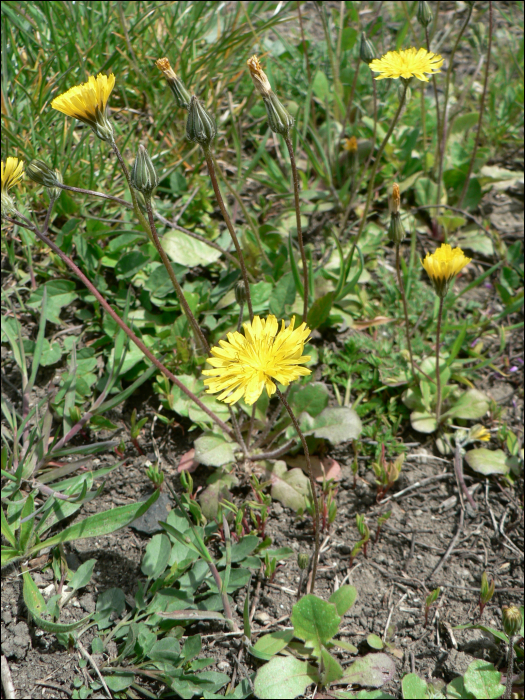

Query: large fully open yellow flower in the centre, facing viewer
[203,315,311,406]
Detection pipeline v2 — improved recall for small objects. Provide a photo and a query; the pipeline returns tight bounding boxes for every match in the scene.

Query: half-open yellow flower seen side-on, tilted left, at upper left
[51,73,115,142]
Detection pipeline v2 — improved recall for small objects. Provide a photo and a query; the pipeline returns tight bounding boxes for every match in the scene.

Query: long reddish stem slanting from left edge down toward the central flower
[18,219,234,437]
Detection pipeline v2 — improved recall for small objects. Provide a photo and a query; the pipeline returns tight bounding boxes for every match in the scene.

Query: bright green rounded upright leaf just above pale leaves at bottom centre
[290,595,341,657]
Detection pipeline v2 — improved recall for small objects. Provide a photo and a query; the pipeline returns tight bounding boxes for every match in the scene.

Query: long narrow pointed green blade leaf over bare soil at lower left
[31,489,160,554]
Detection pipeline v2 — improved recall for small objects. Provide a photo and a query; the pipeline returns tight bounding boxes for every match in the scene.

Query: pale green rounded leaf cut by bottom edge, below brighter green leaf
[254,656,319,700]
